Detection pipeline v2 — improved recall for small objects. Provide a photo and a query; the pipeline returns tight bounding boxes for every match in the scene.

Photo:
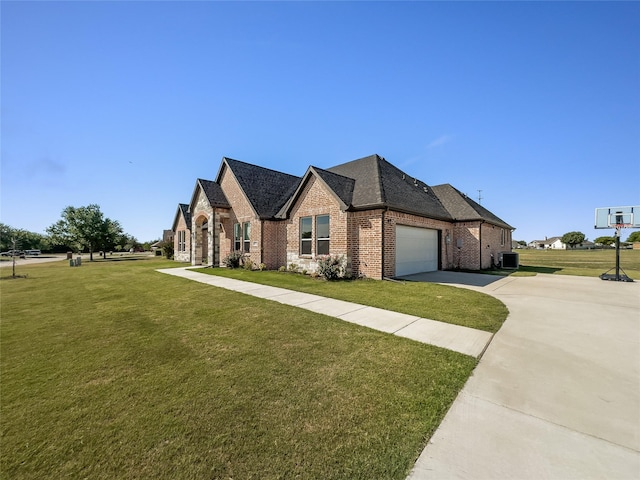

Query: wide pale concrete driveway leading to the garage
[409,272,640,480]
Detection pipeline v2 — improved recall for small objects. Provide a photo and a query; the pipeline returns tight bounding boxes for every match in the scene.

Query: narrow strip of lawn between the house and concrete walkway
[192,268,509,332]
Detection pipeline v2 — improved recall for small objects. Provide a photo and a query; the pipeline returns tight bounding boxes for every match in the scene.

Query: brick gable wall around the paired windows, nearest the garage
[285,176,352,273]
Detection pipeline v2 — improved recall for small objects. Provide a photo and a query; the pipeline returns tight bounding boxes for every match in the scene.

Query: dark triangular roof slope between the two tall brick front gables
[218,157,300,219]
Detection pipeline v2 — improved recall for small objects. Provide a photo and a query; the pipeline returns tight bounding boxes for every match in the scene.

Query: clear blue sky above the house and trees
[0,1,640,241]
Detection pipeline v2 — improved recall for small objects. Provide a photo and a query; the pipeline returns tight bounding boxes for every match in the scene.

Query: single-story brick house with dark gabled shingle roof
[173,155,513,279]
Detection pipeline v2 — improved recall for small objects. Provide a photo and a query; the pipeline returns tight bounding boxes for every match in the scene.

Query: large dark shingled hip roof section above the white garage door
[328,155,452,220]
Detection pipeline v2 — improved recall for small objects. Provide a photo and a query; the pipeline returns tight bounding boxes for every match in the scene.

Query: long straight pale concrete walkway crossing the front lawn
[158,267,493,358]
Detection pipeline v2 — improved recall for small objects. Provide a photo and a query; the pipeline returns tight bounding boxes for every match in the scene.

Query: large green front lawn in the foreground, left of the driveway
[0,259,476,479]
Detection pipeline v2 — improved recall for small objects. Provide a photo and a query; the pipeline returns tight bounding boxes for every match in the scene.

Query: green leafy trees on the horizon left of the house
[0,204,158,260]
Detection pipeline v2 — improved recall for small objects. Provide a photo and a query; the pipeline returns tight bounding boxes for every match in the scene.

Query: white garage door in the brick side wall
[396,225,438,277]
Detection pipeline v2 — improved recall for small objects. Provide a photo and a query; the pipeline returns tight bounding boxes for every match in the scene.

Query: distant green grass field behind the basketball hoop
[516,248,640,280]
